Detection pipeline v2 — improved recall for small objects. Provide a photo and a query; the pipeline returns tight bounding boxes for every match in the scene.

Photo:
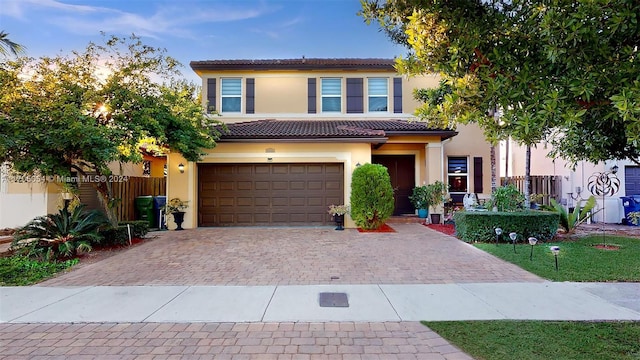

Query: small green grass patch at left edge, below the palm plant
[0,256,78,286]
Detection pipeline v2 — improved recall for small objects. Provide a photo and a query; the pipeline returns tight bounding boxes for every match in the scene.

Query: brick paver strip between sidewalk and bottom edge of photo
[0,322,472,360]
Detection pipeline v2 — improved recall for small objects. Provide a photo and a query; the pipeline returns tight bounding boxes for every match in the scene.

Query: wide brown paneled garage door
[198,164,344,226]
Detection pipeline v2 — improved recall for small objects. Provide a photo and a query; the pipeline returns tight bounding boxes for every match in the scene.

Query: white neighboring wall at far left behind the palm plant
[0,193,48,229]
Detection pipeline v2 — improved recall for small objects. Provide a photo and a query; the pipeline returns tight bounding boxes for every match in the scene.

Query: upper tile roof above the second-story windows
[189,58,395,71]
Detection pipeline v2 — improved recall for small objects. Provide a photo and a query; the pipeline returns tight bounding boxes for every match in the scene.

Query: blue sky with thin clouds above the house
[0,0,405,79]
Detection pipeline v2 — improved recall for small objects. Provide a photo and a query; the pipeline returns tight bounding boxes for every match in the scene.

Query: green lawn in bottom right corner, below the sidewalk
[423,320,640,360]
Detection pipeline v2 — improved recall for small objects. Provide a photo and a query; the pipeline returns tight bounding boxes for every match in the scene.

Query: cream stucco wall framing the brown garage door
[167,143,371,229]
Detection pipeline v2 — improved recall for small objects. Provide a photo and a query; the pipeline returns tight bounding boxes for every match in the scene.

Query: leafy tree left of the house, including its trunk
[0,36,219,224]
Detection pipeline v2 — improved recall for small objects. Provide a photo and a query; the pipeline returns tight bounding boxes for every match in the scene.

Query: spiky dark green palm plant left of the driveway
[11,205,107,260]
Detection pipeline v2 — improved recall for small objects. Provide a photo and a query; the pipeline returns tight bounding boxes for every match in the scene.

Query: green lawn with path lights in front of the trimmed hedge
[474,235,640,282]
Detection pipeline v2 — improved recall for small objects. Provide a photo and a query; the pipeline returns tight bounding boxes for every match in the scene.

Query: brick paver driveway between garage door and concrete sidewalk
[41,224,542,286]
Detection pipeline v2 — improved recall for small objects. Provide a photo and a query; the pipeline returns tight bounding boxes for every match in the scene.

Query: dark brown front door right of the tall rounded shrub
[371,155,416,215]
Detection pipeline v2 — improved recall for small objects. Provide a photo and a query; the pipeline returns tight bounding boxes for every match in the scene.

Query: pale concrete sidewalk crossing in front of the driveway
[0,282,640,323]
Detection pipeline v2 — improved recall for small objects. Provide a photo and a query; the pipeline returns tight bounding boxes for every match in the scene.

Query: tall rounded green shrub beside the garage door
[350,164,395,230]
